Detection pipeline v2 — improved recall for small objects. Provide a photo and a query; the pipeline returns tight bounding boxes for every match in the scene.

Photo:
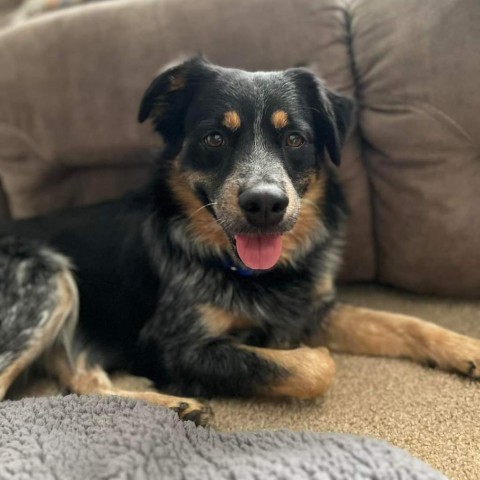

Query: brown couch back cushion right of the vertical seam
[351,0,480,297]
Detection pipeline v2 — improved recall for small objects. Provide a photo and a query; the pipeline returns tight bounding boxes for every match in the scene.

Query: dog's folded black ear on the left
[138,56,212,143]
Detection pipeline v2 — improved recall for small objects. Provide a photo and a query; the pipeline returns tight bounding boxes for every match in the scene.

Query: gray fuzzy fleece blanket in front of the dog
[0,395,445,480]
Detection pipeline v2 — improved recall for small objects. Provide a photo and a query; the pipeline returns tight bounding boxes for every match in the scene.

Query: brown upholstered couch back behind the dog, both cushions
[0,0,480,296]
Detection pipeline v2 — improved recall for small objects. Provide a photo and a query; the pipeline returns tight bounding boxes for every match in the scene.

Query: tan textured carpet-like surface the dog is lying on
[8,286,480,480]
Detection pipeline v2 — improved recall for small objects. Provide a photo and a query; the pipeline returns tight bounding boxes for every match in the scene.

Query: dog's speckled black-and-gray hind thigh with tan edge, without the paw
[0,237,78,400]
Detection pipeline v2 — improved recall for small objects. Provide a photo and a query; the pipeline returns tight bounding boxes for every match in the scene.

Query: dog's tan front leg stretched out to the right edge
[306,304,480,378]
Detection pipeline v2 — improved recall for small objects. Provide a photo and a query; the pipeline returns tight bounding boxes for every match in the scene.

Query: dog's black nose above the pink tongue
[238,184,288,228]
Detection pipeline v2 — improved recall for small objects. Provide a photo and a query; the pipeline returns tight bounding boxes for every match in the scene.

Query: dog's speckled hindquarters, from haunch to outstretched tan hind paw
[0,237,210,424]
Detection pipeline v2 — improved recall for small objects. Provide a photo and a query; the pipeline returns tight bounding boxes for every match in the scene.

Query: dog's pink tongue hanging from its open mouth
[235,235,282,270]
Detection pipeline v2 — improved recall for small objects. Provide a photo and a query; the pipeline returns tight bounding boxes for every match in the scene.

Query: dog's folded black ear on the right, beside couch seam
[287,68,354,166]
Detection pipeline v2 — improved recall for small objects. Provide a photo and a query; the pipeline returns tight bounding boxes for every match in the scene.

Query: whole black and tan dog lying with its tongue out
[0,58,480,423]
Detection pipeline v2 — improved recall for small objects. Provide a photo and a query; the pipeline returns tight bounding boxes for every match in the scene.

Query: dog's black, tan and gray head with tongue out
[139,57,353,270]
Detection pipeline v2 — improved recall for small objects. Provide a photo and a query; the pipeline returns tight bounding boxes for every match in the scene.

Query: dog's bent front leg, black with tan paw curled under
[137,306,335,398]
